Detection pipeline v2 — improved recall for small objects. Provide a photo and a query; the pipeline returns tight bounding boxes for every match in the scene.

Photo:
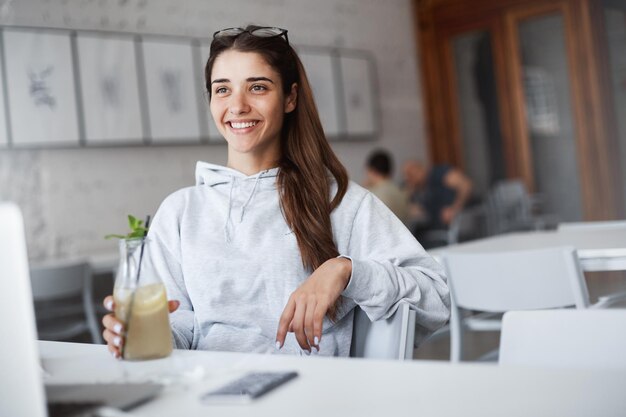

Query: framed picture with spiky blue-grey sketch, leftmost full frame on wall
[3,29,80,147]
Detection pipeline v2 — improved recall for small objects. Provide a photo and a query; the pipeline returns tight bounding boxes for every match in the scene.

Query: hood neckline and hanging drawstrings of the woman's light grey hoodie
[196,162,279,242]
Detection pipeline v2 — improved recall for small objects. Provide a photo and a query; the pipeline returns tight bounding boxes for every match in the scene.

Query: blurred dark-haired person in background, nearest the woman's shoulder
[365,150,409,222]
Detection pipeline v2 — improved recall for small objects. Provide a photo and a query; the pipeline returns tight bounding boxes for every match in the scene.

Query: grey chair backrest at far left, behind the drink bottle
[30,260,91,301]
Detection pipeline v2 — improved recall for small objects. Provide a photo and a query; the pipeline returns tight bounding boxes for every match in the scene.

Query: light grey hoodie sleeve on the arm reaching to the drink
[148,195,195,349]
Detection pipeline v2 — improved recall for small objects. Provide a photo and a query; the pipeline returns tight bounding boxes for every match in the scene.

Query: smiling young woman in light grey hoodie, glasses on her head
[103,26,449,357]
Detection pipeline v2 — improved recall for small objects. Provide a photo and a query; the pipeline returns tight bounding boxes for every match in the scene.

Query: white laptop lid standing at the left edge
[0,203,46,417]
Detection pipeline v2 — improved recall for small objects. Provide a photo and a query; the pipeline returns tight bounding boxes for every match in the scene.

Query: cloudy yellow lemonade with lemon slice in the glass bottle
[113,283,172,360]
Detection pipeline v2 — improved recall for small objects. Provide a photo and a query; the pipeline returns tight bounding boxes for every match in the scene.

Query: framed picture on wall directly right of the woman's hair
[299,49,345,138]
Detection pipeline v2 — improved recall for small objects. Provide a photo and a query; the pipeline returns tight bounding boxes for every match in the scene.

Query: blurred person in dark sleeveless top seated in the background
[403,161,472,239]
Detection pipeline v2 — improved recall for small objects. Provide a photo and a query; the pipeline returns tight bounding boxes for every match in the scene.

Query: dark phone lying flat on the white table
[200,372,298,404]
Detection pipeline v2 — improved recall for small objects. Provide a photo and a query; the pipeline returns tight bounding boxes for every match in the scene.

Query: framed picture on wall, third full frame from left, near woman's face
[142,38,202,143]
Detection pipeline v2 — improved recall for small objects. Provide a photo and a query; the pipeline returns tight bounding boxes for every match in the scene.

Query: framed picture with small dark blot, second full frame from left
[77,33,144,144]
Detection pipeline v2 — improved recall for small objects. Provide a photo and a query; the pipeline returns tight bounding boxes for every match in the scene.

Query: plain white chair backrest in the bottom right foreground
[499,309,626,369]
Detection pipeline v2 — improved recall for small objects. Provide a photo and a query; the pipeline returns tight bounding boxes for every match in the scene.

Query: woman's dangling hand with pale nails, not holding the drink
[276,258,352,353]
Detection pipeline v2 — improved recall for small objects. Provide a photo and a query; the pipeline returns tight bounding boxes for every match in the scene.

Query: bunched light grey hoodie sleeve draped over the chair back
[341,193,450,337]
